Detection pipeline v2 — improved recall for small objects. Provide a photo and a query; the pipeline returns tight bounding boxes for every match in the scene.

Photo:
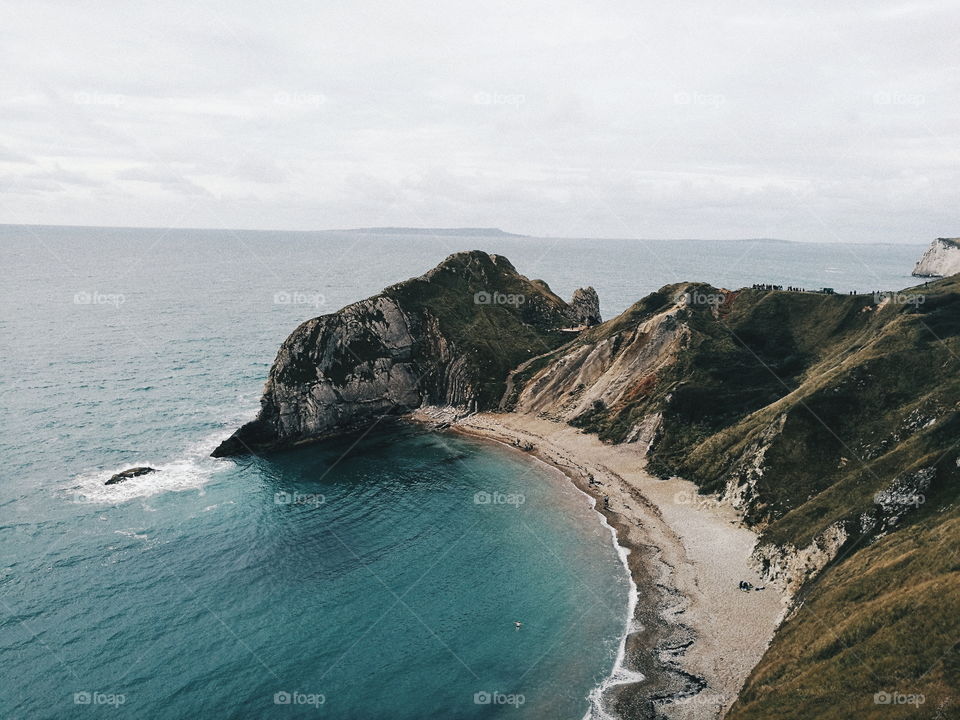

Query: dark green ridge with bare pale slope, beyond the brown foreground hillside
[509,279,960,547]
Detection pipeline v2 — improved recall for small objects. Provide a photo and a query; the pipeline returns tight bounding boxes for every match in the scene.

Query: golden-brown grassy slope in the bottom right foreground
[727,504,960,720]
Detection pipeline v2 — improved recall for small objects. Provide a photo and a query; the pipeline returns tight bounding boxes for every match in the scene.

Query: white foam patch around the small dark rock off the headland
[60,430,238,505]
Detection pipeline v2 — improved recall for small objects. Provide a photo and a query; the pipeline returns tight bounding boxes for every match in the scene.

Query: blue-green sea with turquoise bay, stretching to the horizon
[0,225,926,720]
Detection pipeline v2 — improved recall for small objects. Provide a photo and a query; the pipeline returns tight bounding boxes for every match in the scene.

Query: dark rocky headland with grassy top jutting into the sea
[213,251,599,457]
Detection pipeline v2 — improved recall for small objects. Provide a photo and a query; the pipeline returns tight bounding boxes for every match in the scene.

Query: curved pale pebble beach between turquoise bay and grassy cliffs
[422,408,786,720]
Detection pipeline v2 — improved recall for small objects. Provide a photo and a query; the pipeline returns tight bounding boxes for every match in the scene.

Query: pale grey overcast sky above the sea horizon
[0,0,960,242]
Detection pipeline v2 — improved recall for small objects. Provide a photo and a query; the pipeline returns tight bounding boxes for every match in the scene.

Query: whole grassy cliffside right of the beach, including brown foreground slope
[506,277,960,720]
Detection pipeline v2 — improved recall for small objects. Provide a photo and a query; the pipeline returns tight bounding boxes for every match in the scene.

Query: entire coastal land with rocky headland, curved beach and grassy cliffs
[214,251,960,720]
